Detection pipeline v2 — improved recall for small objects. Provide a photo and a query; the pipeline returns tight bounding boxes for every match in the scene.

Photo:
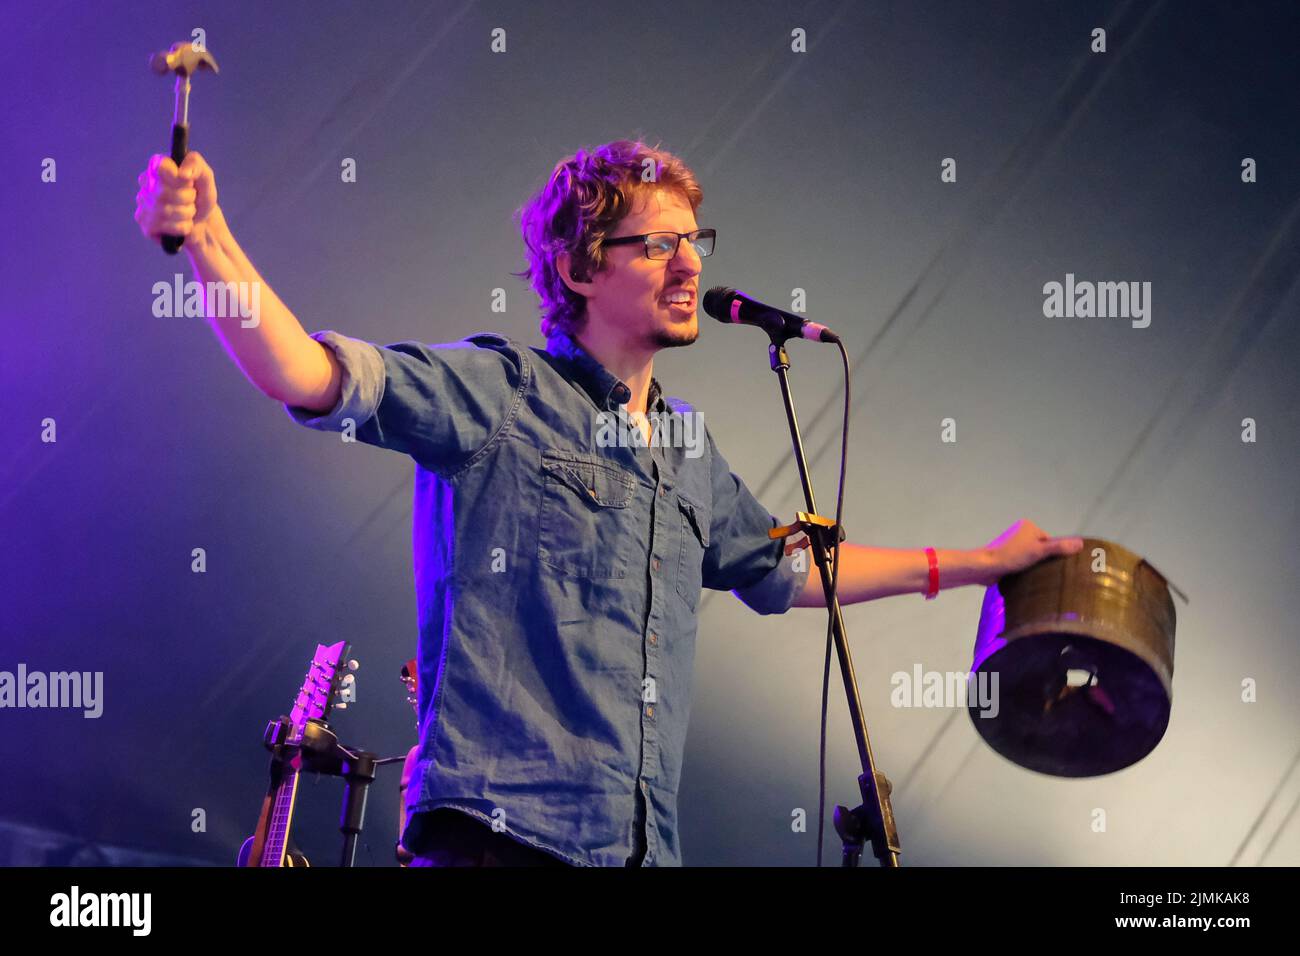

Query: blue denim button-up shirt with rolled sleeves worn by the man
[285,332,807,866]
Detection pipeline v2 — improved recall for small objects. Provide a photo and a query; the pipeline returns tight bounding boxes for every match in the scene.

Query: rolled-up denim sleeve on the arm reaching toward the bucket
[703,428,809,614]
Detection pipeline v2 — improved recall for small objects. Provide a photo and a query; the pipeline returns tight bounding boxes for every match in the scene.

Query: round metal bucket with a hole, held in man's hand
[967,537,1180,777]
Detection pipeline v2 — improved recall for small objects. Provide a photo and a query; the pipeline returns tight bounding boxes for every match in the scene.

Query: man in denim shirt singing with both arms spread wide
[137,140,1082,866]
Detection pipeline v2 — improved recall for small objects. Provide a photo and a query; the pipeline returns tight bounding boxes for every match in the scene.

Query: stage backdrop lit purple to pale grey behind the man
[0,0,1300,865]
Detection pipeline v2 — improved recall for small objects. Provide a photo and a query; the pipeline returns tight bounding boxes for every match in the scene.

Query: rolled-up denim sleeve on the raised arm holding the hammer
[285,330,525,473]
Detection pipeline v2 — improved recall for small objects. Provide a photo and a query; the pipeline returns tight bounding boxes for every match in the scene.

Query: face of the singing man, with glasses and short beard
[586,189,701,349]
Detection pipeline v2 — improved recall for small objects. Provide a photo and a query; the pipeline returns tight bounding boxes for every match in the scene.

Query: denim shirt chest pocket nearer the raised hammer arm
[537,449,636,578]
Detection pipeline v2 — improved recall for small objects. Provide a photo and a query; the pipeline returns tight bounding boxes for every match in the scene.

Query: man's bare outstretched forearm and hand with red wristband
[792,520,1083,607]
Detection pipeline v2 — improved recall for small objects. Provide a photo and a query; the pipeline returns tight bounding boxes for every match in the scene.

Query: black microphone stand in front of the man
[767,328,902,866]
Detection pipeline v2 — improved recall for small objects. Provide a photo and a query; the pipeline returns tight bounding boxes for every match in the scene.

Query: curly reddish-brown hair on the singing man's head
[511,139,705,338]
